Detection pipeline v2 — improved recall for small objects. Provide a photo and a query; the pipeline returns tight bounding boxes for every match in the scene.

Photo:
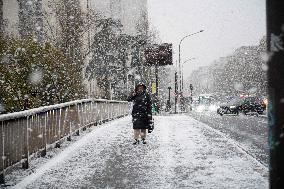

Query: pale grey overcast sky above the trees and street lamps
[148,0,266,76]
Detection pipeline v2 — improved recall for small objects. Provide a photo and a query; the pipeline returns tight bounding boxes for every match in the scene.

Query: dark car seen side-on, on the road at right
[217,97,266,115]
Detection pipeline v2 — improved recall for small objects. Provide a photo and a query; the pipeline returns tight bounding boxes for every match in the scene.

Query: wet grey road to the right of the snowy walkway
[189,112,269,167]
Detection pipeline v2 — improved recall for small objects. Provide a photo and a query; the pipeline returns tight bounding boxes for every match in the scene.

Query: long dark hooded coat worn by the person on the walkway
[127,86,152,129]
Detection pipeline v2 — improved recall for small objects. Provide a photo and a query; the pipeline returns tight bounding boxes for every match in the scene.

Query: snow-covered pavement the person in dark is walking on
[4,115,268,189]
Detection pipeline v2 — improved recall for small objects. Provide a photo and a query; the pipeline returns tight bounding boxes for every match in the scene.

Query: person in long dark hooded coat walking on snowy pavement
[127,83,152,144]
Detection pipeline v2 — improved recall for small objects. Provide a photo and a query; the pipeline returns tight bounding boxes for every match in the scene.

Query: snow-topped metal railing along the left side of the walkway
[0,99,129,183]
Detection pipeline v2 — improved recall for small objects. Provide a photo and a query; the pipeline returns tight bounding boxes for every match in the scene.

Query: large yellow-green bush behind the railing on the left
[0,37,84,112]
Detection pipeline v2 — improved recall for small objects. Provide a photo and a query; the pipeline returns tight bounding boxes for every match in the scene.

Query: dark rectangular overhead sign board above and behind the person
[144,43,173,66]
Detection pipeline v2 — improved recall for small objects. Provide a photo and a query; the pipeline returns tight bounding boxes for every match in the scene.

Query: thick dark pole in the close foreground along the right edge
[266,0,284,189]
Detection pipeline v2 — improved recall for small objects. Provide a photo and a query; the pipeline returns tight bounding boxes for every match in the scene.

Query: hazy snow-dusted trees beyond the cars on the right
[189,38,267,99]
